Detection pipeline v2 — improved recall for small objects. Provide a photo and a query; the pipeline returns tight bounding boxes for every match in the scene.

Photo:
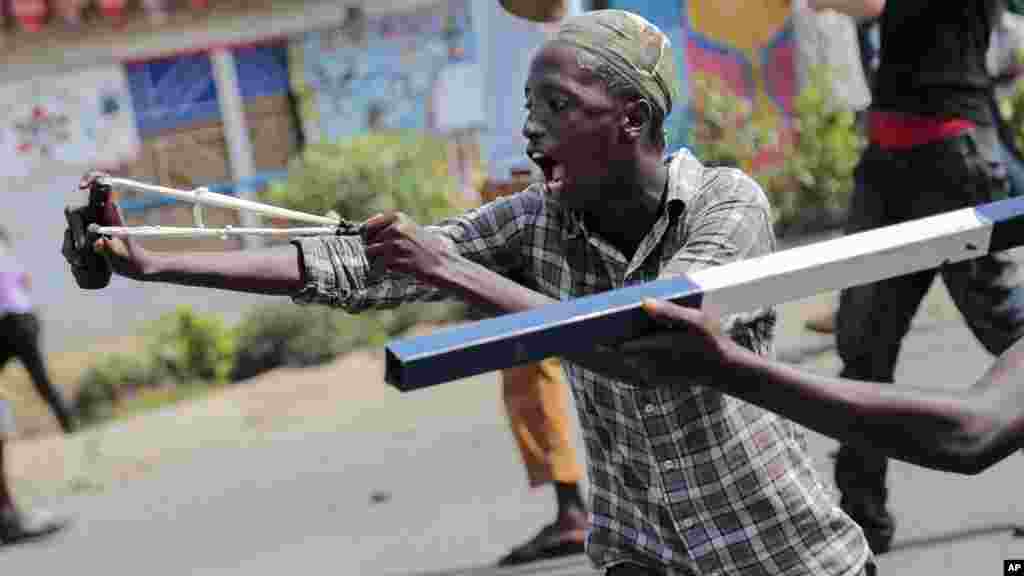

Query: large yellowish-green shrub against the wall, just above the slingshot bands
[261,130,456,223]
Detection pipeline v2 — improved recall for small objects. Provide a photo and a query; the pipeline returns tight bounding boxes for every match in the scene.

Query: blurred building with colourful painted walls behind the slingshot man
[0,0,795,348]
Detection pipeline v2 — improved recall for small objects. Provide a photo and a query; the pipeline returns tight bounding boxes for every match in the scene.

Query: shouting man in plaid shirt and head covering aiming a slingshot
[61,10,873,576]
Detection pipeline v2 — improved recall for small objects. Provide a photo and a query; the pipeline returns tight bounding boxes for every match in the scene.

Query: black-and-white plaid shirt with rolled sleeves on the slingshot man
[294,152,870,576]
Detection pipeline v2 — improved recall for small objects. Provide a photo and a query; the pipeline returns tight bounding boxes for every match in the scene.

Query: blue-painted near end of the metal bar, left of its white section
[385,277,702,390]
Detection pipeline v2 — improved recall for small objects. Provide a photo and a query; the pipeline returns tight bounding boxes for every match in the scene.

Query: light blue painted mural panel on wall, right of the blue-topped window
[289,0,482,141]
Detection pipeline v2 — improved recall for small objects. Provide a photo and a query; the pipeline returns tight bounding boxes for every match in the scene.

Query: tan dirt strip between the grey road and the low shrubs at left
[9,319,452,498]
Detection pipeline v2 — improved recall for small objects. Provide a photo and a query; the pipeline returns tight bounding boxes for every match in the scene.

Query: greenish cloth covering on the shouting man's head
[554,10,680,116]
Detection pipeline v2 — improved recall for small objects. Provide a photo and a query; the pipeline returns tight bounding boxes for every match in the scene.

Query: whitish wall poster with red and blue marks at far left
[0,66,139,176]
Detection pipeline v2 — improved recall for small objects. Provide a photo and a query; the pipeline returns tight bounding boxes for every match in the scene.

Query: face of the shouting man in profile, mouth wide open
[522,42,622,210]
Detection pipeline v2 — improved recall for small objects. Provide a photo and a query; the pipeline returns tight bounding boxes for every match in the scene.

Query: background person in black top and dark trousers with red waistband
[814,0,1024,554]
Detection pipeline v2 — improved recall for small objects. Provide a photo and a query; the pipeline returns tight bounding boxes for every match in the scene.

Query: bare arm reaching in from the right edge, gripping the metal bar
[624,301,1024,474]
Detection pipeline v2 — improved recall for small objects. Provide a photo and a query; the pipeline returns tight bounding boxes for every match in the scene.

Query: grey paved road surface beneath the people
[0,282,1024,576]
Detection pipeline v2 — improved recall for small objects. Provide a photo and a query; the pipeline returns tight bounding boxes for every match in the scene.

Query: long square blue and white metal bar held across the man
[385,198,1024,390]
